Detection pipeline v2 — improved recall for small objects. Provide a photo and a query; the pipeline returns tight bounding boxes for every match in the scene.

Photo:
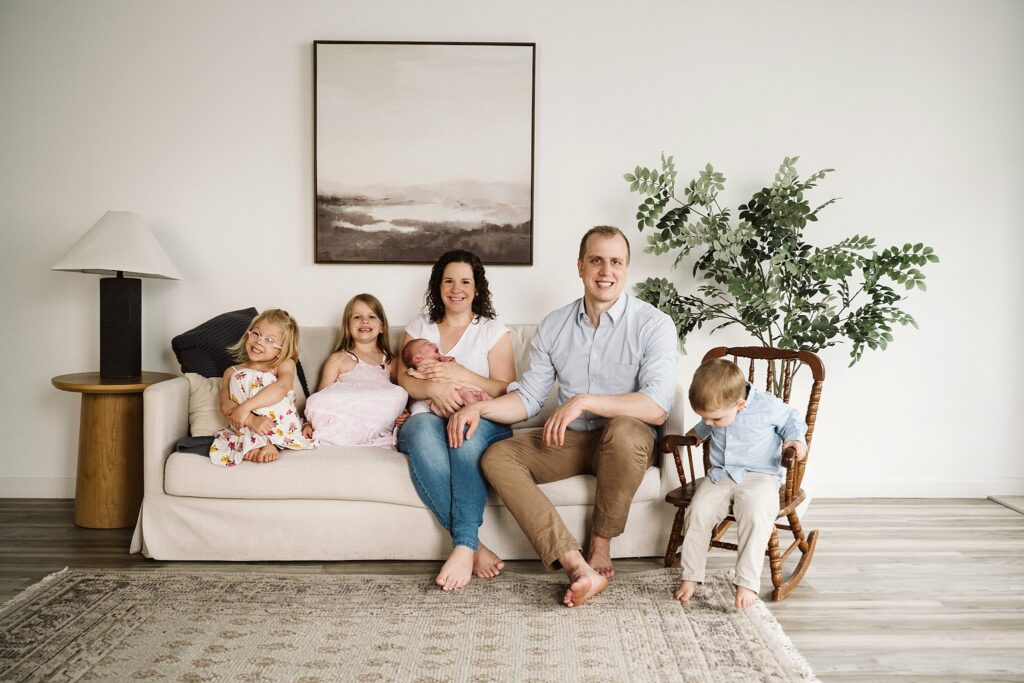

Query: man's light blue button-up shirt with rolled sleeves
[508,294,679,431]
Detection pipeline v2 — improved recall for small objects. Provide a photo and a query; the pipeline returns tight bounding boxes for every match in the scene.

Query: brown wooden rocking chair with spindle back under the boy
[662,346,825,600]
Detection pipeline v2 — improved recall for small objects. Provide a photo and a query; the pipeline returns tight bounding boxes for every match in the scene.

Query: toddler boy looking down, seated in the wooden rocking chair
[675,358,807,607]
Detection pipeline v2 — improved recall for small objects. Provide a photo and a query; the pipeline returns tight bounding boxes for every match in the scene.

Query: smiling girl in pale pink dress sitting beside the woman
[306,294,409,451]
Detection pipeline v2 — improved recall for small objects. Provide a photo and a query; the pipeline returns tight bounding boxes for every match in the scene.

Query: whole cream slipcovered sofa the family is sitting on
[131,325,683,561]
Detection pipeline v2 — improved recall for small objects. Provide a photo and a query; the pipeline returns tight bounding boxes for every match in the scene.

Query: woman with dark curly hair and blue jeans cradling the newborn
[398,250,515,591]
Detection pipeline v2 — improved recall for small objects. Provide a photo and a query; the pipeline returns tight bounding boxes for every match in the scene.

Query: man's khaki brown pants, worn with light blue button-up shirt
[481,417,654,567]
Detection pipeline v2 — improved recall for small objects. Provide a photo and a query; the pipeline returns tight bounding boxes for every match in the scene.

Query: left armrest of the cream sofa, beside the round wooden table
[142,377,188,496]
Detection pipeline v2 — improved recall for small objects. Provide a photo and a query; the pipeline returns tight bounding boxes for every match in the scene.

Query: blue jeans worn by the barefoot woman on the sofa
[398,413,512,551]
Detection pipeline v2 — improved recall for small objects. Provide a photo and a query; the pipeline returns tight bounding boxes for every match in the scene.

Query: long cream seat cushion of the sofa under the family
[164,445,660,507]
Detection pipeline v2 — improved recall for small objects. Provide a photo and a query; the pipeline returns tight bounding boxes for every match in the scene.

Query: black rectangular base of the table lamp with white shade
[99,276,142,380]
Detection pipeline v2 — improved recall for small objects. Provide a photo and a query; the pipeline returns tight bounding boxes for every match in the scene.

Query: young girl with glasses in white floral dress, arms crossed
[210,308,317,467]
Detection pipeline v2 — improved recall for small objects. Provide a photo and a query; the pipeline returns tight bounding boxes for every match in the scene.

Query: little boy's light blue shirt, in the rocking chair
[693,382,807,483]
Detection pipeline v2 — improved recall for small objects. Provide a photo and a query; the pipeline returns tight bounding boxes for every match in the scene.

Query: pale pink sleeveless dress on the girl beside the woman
[305,353,409,451]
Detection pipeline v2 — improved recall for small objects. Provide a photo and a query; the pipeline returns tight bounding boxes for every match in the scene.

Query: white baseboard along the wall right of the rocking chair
[804,478,1024,498]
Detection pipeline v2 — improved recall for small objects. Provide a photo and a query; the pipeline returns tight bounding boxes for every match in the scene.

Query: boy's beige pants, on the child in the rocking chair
[681,472,780,593]
